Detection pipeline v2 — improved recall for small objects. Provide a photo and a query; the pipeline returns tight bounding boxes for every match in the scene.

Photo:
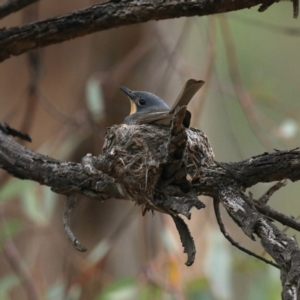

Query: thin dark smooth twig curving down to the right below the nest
[213,197,279,269]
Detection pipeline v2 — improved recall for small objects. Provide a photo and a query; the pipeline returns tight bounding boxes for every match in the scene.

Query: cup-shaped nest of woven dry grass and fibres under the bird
[102,124,214,206]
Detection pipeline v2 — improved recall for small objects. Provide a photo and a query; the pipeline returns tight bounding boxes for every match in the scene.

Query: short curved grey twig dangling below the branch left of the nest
[63,195,87,252]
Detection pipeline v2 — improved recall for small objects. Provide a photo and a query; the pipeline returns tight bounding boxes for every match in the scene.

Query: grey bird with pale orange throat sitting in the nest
[120,79,205,128]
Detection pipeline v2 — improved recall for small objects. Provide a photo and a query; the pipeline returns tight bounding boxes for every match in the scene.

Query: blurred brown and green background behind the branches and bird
[0,0,300,300]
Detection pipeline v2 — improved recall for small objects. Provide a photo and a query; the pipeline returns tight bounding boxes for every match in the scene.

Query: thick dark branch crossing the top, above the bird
[0,0,263,61]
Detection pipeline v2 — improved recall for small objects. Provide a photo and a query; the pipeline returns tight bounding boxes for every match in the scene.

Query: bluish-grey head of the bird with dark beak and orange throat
[120,86,170,115]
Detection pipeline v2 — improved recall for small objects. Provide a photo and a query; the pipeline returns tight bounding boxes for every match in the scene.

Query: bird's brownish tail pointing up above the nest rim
[170,79,205,113]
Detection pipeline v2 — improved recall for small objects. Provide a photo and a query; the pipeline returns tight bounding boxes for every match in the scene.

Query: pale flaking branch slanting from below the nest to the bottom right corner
[219,182,300,300]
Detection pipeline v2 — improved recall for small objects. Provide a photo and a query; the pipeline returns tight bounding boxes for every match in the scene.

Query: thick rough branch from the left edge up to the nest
[0,130,124,200]
